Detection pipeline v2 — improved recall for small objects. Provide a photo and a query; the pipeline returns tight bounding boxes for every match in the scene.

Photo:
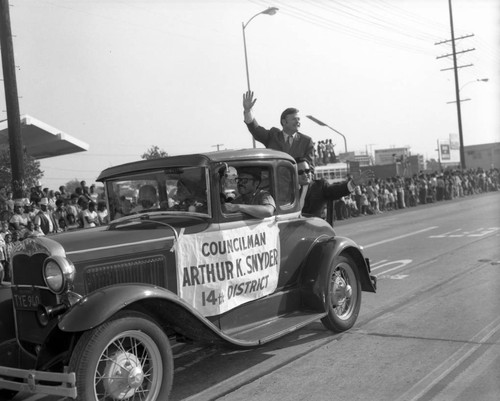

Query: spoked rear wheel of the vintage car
[321,256,361,333]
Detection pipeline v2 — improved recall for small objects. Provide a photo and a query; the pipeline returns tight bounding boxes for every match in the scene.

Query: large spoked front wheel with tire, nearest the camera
[69,311,173,401]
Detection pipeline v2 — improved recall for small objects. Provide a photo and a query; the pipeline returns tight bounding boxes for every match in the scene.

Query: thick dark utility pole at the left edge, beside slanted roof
[0,0,24,199]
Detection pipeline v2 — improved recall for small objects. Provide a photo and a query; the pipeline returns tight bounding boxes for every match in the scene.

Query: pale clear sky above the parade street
[0,0,500,189]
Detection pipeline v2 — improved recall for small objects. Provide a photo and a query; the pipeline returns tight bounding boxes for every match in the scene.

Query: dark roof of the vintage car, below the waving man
[97,149,295,181]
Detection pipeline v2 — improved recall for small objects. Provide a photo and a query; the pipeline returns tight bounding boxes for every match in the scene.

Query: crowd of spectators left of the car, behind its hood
[0,181,108,281]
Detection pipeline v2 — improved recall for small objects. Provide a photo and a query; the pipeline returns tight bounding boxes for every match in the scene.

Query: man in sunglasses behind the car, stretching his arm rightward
[296,158,374,217]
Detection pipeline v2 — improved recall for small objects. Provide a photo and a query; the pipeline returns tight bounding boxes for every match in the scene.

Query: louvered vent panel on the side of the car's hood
[85,255,166,294]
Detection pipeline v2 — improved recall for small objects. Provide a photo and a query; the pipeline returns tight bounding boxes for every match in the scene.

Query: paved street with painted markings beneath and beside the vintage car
[10,193,500,401]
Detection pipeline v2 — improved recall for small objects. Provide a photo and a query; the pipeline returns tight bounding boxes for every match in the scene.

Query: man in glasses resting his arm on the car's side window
[222,167,276,219]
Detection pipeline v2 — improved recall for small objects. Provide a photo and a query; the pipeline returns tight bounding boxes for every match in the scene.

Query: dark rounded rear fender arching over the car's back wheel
[301,237,376,310]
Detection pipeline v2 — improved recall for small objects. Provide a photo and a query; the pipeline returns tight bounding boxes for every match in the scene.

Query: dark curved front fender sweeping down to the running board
[58,284,247,346]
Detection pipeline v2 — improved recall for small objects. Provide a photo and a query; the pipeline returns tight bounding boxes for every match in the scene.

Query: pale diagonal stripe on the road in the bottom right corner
[398,318,500,401]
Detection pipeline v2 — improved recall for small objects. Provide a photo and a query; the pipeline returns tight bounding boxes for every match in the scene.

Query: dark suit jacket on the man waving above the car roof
[247,119,314,167]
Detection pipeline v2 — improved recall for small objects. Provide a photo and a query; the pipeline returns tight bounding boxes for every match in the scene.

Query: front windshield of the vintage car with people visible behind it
[106,167,209,220]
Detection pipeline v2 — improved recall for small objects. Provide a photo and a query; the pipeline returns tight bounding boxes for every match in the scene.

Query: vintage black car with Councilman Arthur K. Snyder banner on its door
[0,149,375,401]
